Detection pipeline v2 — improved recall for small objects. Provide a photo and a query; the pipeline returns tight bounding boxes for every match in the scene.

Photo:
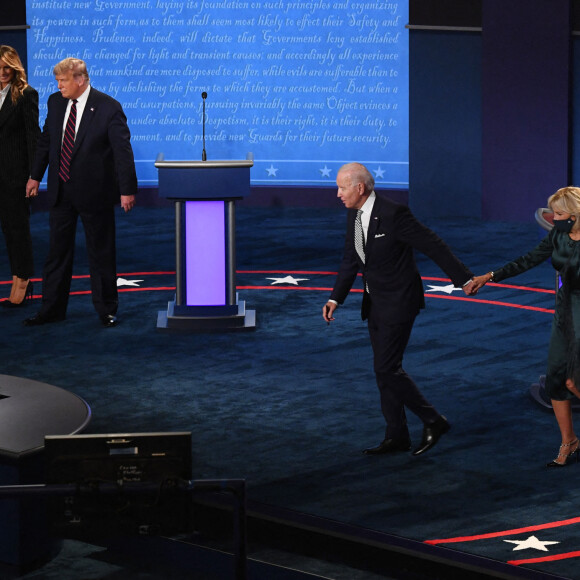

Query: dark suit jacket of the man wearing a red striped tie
[32,87,137,211]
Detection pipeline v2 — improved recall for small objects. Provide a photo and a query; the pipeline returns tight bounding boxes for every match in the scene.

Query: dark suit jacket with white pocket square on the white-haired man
[330,195,473,323]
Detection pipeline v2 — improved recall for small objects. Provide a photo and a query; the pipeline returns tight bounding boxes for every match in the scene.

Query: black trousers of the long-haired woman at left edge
[0,182,34,280]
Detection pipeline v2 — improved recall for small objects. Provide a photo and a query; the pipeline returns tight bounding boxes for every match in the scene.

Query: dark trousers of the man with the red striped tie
[41,184,119,318]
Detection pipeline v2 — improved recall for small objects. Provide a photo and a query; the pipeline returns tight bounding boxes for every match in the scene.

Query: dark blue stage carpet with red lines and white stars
[0,206,580,578]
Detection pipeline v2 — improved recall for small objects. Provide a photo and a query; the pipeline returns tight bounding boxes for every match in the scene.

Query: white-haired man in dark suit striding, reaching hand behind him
[322,163,473,455]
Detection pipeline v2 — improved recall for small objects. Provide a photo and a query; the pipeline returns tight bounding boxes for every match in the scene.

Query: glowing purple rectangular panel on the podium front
[185,201,226,306]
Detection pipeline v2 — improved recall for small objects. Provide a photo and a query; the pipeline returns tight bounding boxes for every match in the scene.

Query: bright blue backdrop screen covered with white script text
[27,0,409,188]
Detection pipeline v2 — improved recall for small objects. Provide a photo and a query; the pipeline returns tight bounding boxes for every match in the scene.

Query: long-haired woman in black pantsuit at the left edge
[0,45,40,308]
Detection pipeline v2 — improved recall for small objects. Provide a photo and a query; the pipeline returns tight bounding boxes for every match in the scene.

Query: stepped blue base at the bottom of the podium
[157,300,256,332]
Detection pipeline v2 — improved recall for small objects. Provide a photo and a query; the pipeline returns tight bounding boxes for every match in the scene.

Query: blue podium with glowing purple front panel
[155,154,256,331]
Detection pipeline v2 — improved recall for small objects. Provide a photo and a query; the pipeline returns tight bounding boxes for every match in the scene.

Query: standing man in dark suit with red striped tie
[24,58,137,327]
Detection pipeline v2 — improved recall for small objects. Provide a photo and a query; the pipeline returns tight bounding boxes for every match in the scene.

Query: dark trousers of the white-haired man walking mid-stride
[368,305,439,439]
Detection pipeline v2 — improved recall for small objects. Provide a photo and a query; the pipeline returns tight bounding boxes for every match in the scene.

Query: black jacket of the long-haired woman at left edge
[0,87,40,188]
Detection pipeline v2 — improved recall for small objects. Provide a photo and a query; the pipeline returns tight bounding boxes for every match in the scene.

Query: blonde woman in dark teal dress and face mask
[471,187,580,467]
